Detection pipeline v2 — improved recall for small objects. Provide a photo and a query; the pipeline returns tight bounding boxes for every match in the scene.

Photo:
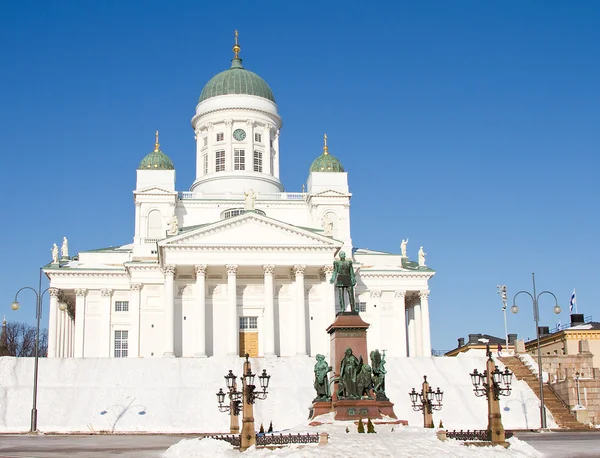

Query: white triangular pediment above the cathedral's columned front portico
[159,212,342,250]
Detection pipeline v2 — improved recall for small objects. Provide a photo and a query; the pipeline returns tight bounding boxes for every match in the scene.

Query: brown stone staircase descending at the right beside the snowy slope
[500,356,589,430]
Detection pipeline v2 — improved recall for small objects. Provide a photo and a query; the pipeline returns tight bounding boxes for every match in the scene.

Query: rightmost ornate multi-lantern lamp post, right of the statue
[469,344,513,445]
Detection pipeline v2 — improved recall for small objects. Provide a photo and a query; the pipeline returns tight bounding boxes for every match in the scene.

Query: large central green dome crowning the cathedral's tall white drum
[198,57,275,103]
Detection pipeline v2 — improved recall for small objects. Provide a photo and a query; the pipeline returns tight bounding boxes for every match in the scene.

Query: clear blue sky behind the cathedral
[0,1,600,349]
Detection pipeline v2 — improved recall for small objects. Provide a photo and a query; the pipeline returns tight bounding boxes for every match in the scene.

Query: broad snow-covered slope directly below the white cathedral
[0,353,556,434]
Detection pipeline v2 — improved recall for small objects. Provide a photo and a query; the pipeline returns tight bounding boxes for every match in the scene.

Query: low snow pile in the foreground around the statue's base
[163,422,542,458]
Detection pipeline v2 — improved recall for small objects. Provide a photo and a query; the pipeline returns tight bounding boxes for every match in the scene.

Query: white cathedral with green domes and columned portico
[44,39,434,358]
